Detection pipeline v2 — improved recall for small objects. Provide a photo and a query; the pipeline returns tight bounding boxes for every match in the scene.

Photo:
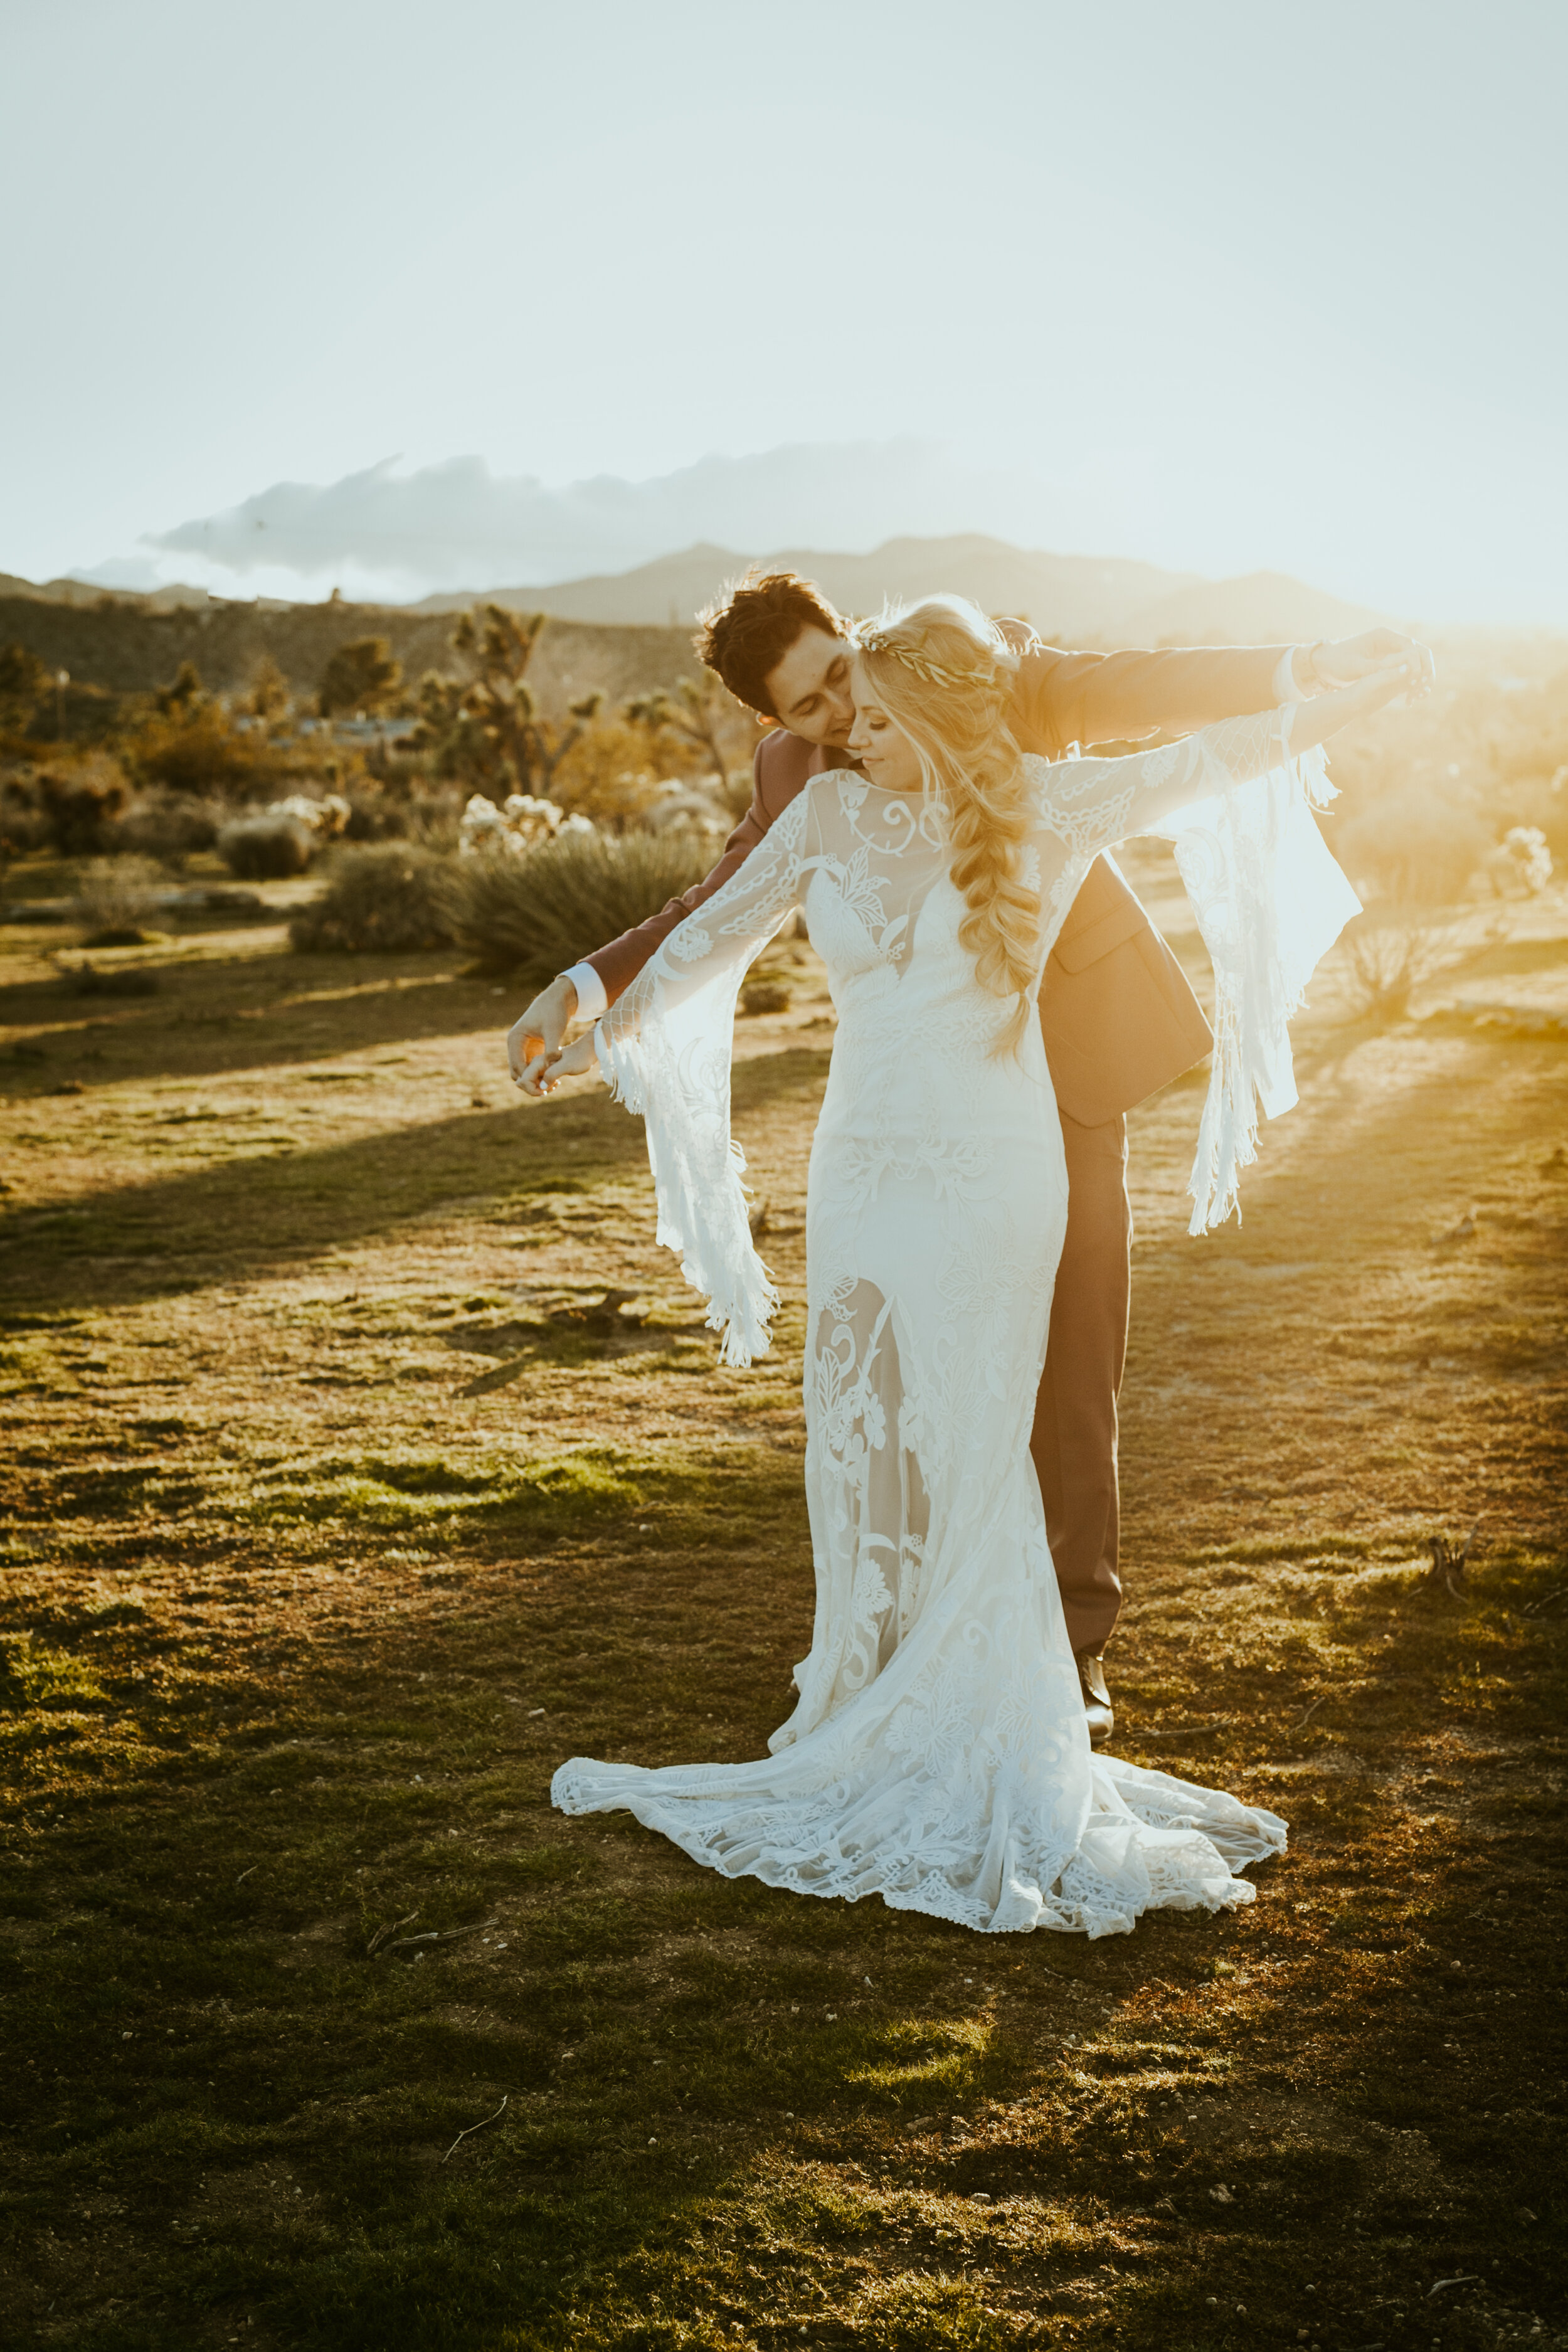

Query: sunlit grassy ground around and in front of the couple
[0,875,1568,2352]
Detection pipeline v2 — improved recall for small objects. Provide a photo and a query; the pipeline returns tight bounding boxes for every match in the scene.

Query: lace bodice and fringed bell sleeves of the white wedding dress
[600,711,1359,1364]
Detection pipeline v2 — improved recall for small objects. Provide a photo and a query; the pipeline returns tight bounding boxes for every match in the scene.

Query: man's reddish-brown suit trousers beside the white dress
[1030,1113,1133,1651]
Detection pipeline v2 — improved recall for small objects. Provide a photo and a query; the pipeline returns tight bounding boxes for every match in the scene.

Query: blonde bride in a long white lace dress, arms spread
[550,598,1411,1936]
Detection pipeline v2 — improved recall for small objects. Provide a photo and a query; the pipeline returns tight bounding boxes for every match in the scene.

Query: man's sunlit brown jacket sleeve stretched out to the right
[1013,640,1300,758]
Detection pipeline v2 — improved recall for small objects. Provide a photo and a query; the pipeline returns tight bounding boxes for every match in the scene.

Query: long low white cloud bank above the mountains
[146,440,1104,595]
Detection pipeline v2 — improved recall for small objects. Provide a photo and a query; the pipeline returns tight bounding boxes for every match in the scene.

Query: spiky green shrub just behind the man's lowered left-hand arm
[452,825,712,981]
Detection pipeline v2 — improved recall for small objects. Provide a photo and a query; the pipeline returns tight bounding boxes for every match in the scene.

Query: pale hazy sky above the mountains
[0,0,1568,626]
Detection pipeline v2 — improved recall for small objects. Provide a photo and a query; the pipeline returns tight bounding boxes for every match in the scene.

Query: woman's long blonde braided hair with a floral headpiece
[854,595,1041,1051]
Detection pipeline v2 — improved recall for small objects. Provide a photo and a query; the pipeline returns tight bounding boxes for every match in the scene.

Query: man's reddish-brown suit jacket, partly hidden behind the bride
[588,621,1286,1126]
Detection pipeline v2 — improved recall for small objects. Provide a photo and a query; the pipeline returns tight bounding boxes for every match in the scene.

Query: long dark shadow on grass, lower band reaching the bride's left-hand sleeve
[0,1051,827,1308]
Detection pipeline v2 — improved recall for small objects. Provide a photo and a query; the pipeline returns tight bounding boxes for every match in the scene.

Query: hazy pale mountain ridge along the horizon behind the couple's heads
[0,532,1387,647]
